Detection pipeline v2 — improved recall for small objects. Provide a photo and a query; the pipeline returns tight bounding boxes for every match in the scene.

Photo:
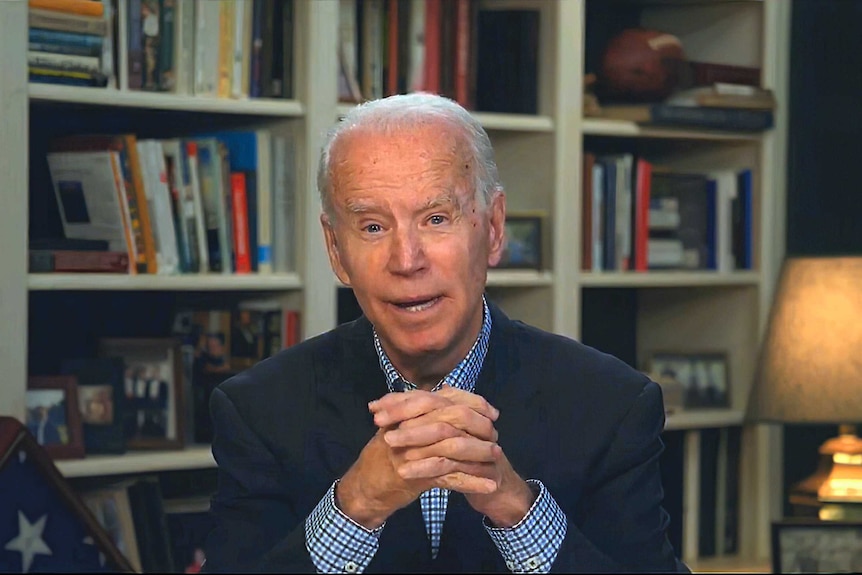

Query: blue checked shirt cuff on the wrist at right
[483,479,567,573]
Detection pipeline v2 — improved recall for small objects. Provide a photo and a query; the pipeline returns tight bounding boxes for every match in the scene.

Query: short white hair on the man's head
[317,92,503,221]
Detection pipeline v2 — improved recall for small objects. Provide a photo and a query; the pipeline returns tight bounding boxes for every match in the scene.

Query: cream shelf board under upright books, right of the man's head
[578,271,760,288]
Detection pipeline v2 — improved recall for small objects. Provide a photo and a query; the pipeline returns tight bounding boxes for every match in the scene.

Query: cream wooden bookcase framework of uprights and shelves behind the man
[0,0,790,565]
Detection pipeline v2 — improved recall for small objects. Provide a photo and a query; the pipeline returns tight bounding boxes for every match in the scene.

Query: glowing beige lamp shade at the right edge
[748,257,862,423]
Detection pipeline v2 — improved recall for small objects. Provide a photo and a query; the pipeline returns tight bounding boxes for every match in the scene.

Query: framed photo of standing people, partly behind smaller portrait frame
[99,338,184,449]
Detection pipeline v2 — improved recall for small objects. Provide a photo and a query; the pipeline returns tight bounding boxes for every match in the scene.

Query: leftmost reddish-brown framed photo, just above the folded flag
[25,375,84,459]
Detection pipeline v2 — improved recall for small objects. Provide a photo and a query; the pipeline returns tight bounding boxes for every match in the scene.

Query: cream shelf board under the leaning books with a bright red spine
[27,273,302,291]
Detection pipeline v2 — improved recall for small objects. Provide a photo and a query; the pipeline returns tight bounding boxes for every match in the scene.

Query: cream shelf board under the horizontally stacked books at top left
[29,83,305,117]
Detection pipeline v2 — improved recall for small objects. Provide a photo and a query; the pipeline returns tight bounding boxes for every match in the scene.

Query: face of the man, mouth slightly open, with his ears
[322,123,505,372]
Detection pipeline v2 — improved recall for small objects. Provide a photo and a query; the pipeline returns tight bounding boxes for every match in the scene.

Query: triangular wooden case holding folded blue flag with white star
[0,416,134,573]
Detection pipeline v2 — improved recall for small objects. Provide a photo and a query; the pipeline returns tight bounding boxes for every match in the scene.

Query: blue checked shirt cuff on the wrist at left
[305,481,385,573]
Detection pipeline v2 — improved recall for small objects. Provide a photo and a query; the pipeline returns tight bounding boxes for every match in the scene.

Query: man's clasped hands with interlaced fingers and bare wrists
[336,385,535,529]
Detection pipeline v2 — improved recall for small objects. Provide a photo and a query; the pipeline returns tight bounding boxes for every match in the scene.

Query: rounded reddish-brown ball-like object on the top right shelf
[598,28,686,102]
